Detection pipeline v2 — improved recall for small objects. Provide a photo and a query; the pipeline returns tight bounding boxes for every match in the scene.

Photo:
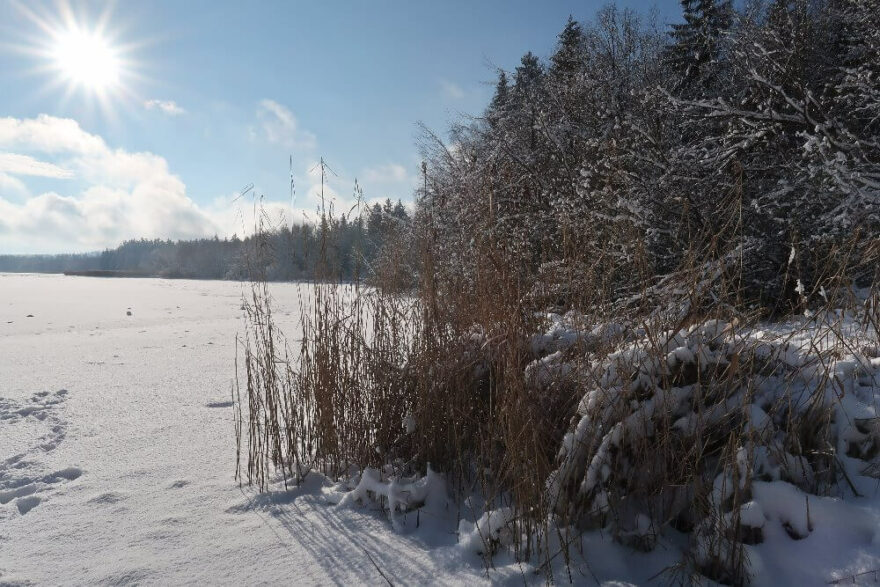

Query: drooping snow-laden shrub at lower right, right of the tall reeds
[548,320,880,583]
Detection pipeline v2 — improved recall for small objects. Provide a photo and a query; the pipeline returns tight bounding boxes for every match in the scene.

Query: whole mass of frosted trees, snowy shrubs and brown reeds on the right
[235,0,880,584]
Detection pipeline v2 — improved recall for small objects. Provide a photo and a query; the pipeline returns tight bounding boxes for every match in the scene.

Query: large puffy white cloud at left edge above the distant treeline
[0,115,220,251]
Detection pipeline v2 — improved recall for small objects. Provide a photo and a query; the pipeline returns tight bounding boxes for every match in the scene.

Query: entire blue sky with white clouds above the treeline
[0,0,679,253]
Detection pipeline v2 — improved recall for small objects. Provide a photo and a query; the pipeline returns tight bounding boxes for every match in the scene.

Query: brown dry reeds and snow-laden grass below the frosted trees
[230,172,880,584]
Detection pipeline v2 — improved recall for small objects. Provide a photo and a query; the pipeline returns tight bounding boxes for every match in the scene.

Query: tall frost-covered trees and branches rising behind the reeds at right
[419,0,880,311]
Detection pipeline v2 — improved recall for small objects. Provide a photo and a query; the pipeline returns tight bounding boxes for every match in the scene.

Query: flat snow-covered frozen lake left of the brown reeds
[0,274,498,584]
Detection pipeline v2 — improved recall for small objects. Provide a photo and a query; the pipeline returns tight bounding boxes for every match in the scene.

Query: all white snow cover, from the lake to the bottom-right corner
[0,274,880,585]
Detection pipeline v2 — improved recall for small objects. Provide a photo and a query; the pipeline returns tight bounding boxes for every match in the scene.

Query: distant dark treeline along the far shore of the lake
[0,200,410,281]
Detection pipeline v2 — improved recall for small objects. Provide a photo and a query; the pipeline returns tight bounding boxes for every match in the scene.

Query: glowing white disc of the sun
[52,28,121,93]
